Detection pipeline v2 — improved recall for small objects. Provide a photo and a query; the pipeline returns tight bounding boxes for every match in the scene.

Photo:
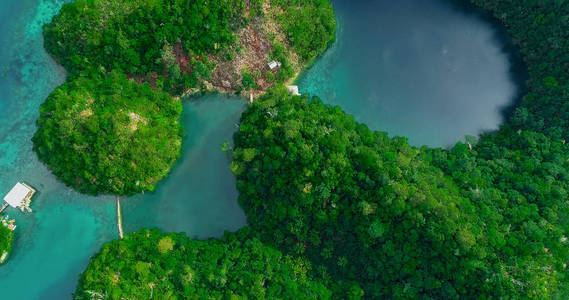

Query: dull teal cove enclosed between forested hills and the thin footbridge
[123,95,246,239]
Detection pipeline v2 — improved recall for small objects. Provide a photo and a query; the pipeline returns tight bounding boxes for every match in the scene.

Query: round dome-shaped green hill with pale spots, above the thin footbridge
[33,73,182,195]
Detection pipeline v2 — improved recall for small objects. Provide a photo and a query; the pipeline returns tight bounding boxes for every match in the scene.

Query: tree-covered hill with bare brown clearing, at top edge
[44,0,336,96]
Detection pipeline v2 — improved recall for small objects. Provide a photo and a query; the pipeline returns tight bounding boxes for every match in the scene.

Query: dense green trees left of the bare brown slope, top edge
[44,0,245,74]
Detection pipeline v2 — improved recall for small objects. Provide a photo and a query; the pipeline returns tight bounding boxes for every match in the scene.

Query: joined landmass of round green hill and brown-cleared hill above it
[33,0,336,196]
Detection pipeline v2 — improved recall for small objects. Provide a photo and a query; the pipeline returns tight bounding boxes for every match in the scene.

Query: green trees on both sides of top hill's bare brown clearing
[44,0,336,95]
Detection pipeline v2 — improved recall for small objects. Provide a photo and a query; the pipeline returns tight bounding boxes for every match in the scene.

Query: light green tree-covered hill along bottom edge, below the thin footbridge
[74,230,331,299]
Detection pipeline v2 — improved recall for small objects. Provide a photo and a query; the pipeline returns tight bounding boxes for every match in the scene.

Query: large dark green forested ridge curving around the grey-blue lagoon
[57,0,569,299]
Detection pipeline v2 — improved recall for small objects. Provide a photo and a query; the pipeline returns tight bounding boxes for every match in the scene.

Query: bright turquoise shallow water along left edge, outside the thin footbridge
[0,0,115,299]
